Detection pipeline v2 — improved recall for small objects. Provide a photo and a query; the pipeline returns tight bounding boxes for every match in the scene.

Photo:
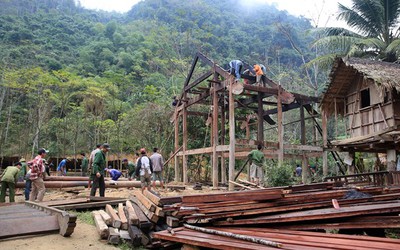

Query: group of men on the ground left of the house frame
[0,143,164,202]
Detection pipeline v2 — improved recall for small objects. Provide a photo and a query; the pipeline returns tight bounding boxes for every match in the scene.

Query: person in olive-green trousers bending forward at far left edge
[0,162,22,203]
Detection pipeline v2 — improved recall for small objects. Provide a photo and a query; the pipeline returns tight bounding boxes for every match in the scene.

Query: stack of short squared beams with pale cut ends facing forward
[88,190,181,248]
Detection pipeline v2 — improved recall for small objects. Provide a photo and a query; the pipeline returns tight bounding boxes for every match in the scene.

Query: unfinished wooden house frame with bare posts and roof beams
[172,52,323,190]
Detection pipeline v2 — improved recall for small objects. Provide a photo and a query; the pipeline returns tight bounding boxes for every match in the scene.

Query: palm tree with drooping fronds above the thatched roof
[310,0,400,66]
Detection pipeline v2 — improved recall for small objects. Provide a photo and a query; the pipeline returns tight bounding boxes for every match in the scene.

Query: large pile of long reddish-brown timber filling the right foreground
[148,183,400,249]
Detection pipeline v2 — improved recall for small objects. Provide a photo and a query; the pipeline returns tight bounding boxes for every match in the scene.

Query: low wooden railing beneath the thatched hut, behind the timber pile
[324,171,400,186]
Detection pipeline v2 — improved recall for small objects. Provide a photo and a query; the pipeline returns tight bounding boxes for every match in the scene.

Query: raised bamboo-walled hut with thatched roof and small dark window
[321,58,400,170]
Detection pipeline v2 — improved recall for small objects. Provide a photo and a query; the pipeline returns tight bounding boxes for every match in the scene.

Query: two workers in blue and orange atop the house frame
[228,60,267,87]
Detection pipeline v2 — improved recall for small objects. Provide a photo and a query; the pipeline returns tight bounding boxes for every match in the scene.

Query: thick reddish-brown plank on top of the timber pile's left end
[182,189,282,203]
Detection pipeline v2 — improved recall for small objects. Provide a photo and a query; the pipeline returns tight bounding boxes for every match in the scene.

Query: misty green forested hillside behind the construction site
[0,0,321,160]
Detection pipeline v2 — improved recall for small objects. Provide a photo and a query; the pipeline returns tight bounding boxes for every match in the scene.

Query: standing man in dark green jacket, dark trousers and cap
[90,143,110,197]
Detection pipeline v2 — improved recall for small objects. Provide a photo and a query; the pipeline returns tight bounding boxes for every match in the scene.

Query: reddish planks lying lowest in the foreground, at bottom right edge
[154,227,400,250]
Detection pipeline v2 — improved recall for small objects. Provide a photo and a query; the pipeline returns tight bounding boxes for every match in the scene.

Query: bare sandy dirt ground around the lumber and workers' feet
[0,183,221,250]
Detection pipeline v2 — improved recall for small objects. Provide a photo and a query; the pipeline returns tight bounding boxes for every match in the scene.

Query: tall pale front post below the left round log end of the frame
[229,78,236,191]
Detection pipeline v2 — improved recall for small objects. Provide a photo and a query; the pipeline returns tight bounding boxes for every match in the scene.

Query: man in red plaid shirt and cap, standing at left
[28,148,49,201]
